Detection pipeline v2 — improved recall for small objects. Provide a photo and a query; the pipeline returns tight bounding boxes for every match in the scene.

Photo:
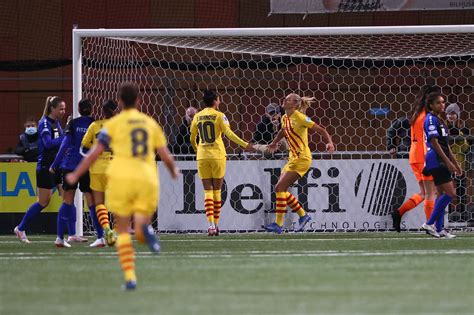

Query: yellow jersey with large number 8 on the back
[98,108,166,182]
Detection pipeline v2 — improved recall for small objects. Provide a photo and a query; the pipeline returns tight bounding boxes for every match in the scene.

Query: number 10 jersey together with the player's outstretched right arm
[191,107,248,160]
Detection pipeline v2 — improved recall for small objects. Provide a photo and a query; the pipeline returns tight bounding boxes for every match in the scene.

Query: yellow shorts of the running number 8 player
[105,177,159,217]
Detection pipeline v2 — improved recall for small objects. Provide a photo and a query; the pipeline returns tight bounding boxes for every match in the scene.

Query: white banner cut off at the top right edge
[270,0,474,14]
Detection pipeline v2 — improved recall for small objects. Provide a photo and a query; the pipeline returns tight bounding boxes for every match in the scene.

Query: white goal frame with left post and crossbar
[72,25,474,235]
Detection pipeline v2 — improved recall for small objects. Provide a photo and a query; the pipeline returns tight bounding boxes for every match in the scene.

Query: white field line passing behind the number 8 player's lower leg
[0,249,474,260]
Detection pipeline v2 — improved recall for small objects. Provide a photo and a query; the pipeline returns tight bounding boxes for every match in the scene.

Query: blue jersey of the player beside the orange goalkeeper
[423,113,449,170]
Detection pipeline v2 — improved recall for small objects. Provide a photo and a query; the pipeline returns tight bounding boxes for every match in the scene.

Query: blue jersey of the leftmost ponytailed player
[37,116,63,170]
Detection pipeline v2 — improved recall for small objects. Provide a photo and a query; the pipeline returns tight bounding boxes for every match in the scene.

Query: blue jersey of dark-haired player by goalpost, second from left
[52,116,94,171]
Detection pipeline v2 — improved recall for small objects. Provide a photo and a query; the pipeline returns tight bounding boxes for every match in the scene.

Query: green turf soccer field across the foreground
[0,233,474,315]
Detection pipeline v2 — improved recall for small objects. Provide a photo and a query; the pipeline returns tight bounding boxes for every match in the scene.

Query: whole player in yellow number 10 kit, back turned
[190,90,254,236]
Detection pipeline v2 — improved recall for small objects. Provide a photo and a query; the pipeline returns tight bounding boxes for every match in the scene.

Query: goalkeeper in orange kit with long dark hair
[392,85,441,232]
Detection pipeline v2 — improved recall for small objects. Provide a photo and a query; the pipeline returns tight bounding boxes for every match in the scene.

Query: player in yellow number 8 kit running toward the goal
[66,83,178,290]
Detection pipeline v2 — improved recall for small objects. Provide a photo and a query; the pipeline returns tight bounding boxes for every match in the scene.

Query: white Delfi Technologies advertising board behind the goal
[158,159,424,231]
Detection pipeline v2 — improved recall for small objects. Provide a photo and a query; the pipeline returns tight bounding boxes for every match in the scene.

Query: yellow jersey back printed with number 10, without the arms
[193,107,228,160]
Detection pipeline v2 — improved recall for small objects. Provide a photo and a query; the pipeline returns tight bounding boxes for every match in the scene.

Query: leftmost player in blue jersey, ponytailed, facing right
[14,96,66,243]
